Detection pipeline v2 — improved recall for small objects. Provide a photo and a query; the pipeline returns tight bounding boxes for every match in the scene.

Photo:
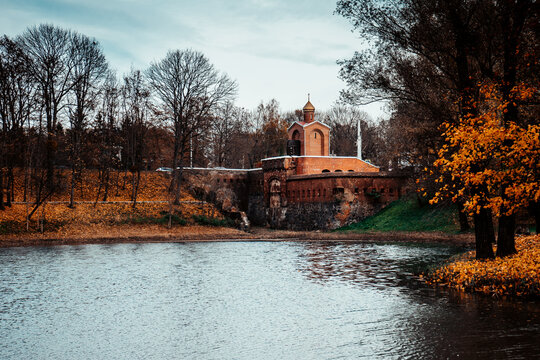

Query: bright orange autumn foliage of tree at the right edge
[430,84,540,257]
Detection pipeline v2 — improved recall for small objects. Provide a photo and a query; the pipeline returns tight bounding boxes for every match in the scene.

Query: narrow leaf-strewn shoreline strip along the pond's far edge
[0,225,474,248]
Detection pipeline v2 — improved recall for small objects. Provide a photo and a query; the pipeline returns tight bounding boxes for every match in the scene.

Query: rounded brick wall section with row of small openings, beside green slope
[266,173,407,230]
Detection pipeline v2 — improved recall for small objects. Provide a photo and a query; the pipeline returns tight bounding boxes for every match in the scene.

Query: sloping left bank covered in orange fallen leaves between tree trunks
[0,170,231,236]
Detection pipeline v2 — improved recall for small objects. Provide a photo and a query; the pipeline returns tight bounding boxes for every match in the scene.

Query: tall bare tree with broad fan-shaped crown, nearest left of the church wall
[146,50,237,203]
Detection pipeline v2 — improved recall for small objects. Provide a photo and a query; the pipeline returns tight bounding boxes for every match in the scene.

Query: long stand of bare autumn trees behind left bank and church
[0,24,379,219]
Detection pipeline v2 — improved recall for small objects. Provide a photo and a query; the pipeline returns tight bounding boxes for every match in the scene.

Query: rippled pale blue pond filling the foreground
[0,242,540,359]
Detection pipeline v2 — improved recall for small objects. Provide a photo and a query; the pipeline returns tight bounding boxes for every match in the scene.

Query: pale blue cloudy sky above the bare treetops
[0,0,384,118]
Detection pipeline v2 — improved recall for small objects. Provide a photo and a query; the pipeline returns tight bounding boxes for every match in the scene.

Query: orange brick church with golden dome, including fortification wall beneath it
[185,98,407,230]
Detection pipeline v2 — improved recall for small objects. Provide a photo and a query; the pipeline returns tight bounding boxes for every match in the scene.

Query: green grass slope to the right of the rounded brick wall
[337,197,459,233]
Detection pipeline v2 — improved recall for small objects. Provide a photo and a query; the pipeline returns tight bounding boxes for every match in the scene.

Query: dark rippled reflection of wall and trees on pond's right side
[299,243,540,359]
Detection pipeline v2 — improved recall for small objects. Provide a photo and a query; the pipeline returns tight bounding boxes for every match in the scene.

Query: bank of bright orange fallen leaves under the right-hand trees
[424,235,540,299]
